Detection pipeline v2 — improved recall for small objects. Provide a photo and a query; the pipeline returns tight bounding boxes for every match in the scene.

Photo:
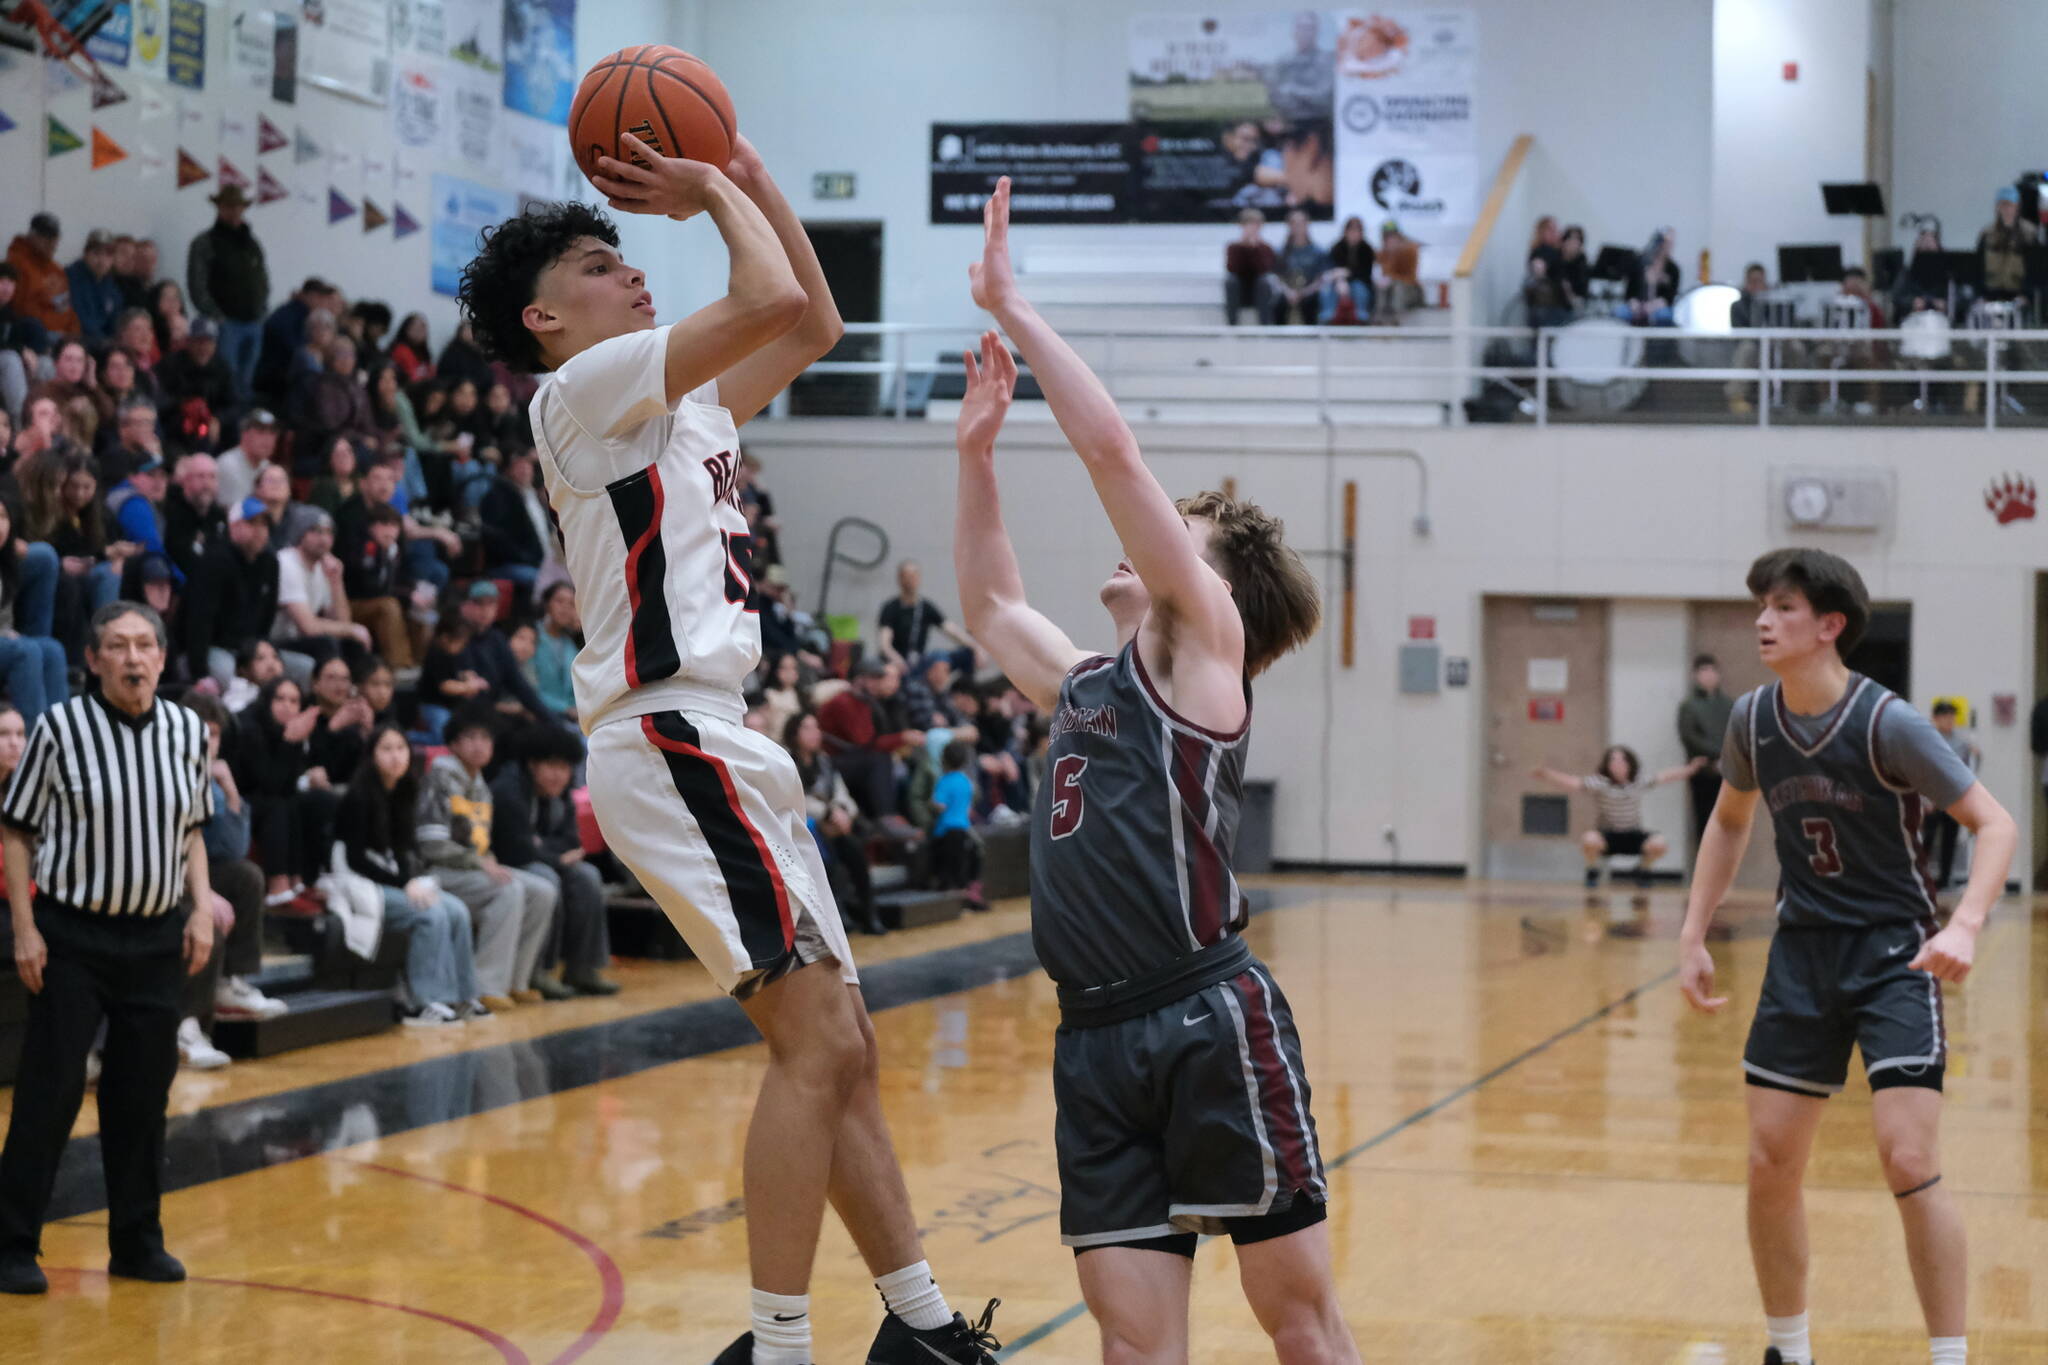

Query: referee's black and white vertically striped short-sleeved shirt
[0,692,213,915]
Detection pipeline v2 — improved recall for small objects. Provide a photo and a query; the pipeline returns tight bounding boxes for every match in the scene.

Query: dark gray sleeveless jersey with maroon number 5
[1030,641,1251,990]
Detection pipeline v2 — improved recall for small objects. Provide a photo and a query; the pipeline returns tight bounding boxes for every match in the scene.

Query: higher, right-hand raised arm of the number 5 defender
[969,176,1243,653]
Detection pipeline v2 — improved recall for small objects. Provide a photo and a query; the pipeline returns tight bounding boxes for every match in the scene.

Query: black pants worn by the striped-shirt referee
[0,900,184,1259]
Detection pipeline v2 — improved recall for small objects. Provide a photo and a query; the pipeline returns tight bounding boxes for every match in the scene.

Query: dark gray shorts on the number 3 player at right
[1743,921,1948,1097]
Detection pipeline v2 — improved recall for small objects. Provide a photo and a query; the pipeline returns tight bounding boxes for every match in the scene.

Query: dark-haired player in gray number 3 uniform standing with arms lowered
[1679,548,2019,1365]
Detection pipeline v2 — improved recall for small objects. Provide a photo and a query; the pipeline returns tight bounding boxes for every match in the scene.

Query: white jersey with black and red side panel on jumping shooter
[530,327,762,735]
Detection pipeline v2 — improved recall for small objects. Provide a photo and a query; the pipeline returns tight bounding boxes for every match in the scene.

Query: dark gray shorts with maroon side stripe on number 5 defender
[1053,966,1329,1254]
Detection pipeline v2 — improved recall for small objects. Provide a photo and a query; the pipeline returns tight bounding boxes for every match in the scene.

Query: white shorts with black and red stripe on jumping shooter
[590,710,858,999]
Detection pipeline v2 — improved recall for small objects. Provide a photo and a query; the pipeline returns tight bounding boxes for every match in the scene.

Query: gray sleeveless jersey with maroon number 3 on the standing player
[1739,673,1935,929]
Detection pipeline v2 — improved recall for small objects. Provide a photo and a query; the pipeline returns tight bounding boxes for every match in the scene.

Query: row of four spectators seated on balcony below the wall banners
[1223,209,1423,327]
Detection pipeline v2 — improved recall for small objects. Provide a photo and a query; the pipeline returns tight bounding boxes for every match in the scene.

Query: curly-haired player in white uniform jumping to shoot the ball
[461,135,995,1365]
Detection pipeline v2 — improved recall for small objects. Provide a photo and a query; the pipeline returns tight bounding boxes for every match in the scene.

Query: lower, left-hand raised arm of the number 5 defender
[952,332,1087,712]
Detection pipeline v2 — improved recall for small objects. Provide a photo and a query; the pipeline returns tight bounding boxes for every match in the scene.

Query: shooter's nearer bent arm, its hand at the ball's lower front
[590,133,811,417]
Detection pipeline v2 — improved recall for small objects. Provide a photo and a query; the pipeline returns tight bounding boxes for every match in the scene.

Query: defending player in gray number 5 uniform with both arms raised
[952,178,1358,1365]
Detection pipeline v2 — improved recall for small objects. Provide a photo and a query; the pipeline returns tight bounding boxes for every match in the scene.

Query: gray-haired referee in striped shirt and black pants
[0,602,213,1293]
